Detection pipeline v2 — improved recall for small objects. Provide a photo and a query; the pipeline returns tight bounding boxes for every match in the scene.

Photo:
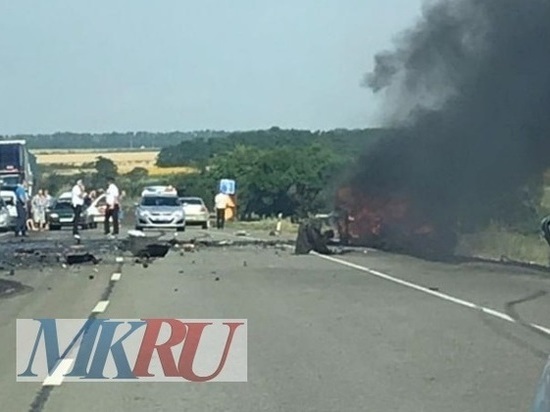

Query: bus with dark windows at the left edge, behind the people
[0,140,35,196]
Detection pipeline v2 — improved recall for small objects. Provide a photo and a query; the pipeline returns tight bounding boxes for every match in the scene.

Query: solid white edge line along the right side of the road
[311,252,550,335]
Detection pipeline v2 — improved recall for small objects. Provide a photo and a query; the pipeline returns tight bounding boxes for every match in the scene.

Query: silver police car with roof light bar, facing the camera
[135,192,185,231]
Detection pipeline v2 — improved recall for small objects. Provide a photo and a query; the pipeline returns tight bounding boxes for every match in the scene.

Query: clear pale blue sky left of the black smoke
[0,0,422,134]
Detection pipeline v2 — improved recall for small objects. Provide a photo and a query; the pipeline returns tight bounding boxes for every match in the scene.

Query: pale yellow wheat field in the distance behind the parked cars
[33,150,194,176]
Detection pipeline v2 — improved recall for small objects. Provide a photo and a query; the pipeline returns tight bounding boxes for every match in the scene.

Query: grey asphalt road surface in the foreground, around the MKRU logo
[0,229,550,412]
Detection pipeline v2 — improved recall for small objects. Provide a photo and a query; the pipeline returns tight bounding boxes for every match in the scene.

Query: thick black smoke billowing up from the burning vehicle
[350,0,550,248]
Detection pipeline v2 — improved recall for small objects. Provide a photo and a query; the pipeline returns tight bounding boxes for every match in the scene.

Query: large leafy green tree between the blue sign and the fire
[210,145,344,219]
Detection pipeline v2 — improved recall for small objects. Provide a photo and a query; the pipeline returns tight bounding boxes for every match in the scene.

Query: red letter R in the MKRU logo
[133,319,187,377]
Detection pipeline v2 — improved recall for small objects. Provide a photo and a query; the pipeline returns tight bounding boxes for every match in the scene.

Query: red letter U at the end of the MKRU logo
[178,322,244,382]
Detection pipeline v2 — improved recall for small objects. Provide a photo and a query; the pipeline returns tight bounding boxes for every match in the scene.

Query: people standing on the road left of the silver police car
[11,179,124,239]
